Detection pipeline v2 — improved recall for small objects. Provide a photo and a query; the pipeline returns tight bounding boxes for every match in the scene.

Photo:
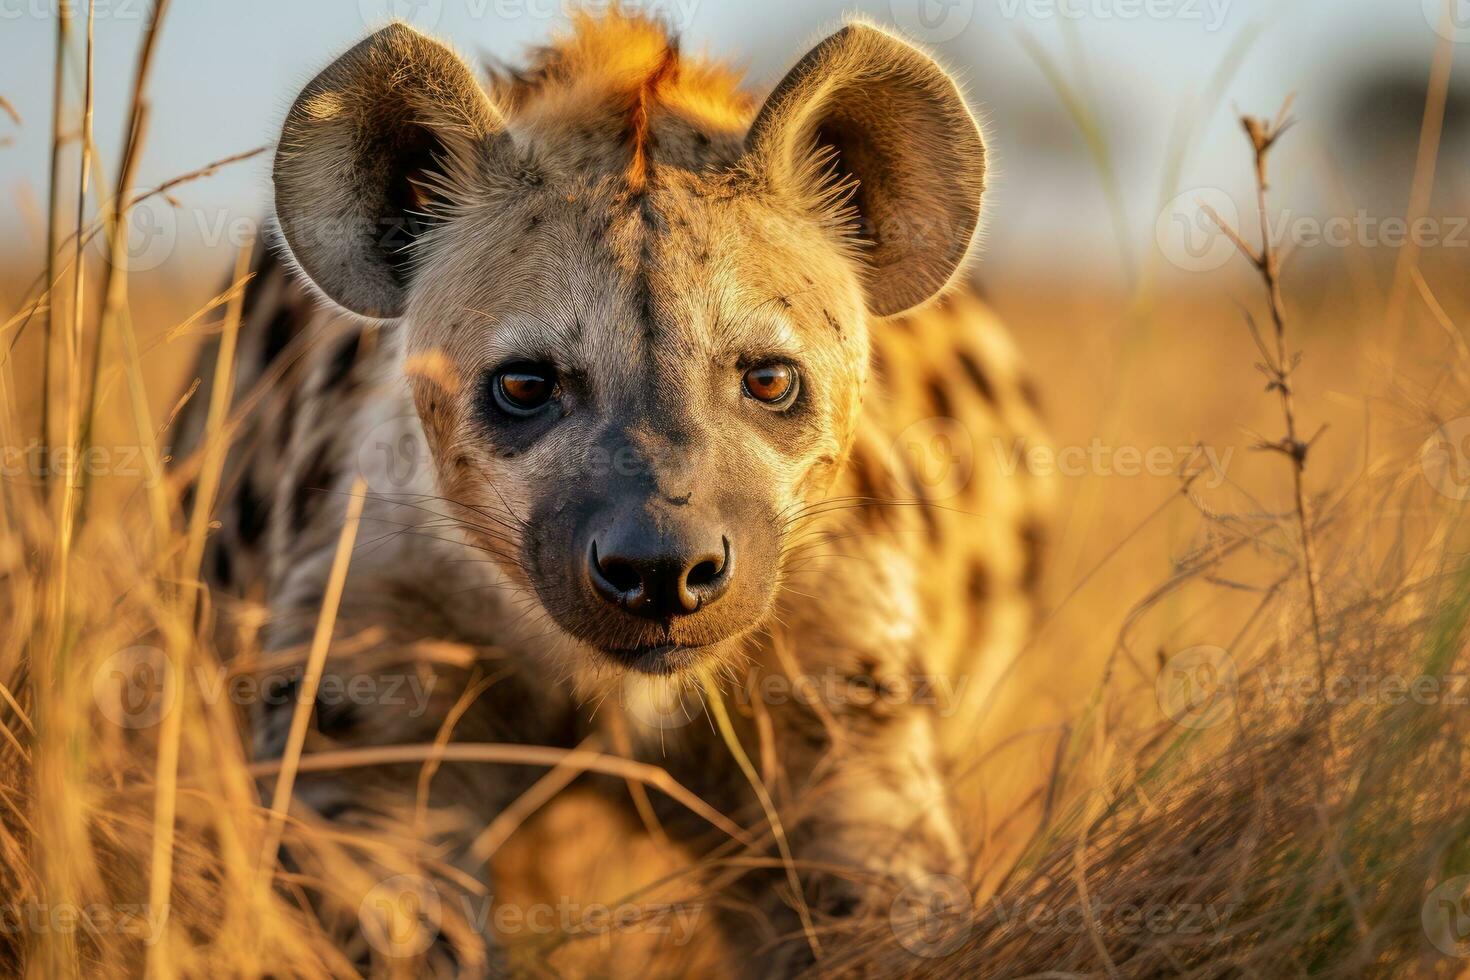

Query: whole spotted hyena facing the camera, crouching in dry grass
[184,16,1042,976]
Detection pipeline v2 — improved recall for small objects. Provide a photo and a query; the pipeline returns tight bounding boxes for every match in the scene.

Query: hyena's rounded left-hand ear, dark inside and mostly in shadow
[273,24,509,319]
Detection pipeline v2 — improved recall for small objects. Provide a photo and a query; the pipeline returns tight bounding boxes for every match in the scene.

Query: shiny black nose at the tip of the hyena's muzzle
[587,530,735,620]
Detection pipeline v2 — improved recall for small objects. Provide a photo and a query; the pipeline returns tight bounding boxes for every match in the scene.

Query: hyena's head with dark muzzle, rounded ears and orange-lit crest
[275,18,985,673]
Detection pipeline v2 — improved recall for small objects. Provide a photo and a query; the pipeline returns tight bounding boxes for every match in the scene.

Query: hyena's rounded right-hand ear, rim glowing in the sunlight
[747,24,985,316]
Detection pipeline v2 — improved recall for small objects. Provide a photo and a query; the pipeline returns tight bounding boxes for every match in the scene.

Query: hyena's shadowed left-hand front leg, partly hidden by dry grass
[253,614,569,976]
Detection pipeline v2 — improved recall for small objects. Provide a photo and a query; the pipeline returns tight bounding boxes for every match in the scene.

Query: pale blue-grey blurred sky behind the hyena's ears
[0,0,1470,282]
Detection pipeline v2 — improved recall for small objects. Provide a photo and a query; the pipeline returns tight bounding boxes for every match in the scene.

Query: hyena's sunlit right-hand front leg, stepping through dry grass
[635,657,966,976]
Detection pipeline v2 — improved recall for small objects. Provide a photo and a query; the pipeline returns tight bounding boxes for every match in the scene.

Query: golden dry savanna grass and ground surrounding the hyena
[0,3,1470,977]
